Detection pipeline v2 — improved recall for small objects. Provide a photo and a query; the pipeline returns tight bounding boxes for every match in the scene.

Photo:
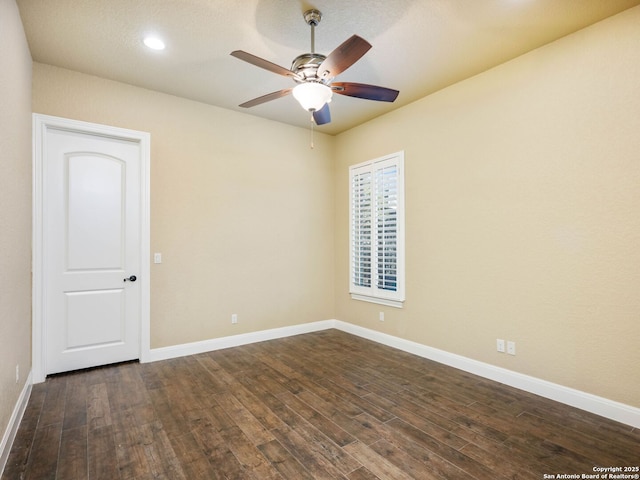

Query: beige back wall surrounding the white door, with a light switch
[33,63,334,348]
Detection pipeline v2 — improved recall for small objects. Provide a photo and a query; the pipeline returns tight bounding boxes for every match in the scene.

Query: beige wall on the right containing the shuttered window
[335,7,640,407]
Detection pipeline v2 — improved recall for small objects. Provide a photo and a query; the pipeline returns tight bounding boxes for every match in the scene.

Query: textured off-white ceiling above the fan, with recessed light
[17,0,640,134]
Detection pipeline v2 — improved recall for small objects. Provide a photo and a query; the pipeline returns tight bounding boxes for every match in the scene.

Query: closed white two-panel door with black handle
[35,114,147,375]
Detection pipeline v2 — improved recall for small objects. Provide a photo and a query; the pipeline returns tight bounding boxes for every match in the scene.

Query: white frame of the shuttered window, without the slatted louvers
[349,151,405,308]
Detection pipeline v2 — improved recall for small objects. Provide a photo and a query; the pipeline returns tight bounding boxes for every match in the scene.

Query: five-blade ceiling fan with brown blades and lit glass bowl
[231,9,400,125]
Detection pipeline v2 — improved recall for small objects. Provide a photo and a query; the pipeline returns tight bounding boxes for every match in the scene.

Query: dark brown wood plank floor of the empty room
[2,330,640,480]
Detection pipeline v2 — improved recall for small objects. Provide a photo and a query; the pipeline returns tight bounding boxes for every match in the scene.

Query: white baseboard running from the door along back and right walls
[143,320,640,428]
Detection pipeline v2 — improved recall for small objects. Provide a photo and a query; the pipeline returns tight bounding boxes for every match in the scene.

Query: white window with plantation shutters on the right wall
[349,152,405,307]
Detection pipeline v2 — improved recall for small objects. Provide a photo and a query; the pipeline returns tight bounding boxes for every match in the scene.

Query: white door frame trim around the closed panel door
[31,113,151,383]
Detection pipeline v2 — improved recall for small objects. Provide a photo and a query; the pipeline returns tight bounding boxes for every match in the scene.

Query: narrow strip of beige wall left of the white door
[0,0,31,444]
